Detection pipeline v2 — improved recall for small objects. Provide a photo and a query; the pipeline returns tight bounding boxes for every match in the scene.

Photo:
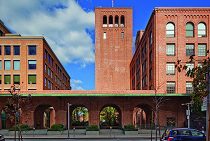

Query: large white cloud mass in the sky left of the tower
[0,0,95,66]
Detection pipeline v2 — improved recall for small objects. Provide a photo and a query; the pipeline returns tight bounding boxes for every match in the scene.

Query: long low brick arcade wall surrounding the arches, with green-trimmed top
[0,91,190,127]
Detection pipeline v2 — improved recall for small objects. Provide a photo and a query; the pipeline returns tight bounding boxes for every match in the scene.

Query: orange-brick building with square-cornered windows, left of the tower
[0,22,70,91]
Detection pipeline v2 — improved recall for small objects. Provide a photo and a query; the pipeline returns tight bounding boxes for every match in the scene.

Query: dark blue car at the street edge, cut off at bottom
[160,128,206,141]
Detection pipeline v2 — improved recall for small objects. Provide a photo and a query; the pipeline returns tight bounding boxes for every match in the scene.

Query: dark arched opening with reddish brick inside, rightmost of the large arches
[133,104,154,128]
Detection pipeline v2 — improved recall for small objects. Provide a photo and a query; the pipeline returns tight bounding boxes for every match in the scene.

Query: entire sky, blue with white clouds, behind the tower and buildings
[0,0,210,90]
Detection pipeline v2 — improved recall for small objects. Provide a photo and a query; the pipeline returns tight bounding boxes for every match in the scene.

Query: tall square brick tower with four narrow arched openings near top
[95,8,133,90]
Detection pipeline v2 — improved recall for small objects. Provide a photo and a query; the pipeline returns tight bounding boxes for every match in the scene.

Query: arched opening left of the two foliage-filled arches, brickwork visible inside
[34,105,55,129]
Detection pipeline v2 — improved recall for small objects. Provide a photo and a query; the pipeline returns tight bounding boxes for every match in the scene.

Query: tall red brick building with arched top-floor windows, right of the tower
[130,8,210,94]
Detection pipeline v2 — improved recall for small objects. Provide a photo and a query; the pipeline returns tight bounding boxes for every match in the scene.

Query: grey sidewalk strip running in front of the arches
[0,130,162,139]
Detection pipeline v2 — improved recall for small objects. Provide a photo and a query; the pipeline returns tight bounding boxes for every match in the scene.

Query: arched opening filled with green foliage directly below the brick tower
[99,104,122,128]
